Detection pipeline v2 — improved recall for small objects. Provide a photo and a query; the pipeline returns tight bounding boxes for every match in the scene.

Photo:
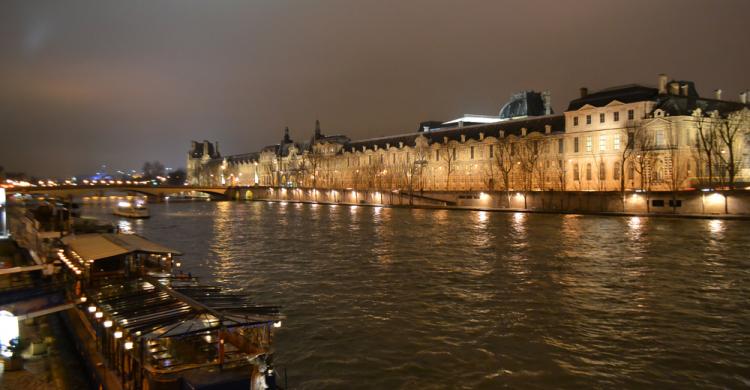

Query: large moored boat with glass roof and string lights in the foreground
[56,233,282,389]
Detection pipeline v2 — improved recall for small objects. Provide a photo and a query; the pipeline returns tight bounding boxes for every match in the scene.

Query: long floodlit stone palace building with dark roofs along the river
[187,75,750,191]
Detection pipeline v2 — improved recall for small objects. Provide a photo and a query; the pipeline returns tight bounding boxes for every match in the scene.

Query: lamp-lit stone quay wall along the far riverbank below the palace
[227,187,750,216]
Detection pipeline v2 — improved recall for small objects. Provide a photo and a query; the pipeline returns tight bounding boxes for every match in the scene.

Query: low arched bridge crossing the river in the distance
[5,184,236,199]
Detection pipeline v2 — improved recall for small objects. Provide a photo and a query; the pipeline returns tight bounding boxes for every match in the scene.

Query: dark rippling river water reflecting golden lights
[84,202,750,389]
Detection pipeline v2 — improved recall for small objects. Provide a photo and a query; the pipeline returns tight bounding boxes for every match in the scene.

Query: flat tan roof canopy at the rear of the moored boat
[62,233,182,261]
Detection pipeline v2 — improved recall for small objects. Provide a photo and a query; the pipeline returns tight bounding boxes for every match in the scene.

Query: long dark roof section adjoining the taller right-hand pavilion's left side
[346,115,565,151]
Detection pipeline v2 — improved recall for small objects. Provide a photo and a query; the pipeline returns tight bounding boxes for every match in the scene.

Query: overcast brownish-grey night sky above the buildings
[0,0,750,176]
